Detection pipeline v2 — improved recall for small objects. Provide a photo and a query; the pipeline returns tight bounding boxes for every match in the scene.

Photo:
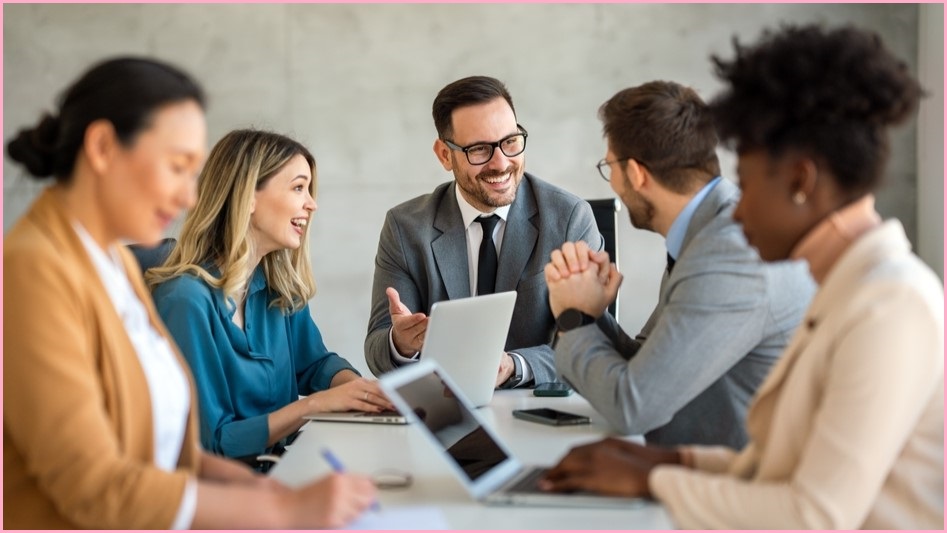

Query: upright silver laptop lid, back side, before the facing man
[421,291,516,407]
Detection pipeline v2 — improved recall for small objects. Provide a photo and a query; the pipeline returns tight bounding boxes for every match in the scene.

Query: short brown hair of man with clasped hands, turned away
[598,81,720,193]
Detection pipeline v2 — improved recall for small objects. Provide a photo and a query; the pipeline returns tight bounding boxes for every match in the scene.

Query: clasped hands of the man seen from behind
[545,241,622,318]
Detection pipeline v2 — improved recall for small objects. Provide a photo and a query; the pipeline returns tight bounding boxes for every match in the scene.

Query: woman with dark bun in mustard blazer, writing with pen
[3,58,375,529]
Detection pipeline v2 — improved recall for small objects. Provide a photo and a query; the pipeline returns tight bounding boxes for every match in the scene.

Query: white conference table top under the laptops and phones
[270,390,674,530]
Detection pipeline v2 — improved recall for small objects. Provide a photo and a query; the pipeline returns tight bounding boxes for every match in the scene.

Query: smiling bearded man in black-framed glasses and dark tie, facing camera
[365,76,603,388]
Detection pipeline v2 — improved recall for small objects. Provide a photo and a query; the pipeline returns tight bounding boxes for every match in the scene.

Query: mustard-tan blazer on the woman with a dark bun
[3,189,200,529]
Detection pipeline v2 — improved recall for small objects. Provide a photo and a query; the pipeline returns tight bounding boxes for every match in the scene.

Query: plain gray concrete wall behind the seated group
[3,4,928,369]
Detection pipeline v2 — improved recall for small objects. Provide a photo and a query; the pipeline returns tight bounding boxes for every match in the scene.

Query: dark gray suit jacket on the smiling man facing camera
[365,173,602,383]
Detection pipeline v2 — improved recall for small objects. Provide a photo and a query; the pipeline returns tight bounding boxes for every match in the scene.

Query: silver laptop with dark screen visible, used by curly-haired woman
[380,360,645,509]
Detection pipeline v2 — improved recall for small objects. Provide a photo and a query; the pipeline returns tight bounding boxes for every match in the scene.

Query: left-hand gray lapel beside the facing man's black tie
[431,184,470,300]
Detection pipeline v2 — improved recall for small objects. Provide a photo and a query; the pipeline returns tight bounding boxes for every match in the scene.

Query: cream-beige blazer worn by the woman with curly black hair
[649,221,944,529]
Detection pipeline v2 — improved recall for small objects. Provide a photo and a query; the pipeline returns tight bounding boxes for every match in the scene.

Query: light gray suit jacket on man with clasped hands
[556,180,815,449]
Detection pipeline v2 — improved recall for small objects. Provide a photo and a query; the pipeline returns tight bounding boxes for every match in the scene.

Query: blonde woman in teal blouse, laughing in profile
[146,130,393,458]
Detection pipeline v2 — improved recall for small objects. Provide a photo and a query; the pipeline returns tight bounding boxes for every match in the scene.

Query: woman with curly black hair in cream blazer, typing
[544,22,944,529]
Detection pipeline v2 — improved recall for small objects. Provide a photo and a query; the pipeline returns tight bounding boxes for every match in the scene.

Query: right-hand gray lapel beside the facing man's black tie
[496,174,539,292]
